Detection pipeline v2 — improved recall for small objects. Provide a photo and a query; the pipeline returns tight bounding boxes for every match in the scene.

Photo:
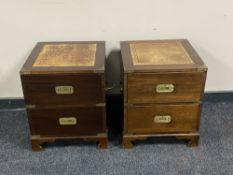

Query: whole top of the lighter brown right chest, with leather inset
[121,40,206,72]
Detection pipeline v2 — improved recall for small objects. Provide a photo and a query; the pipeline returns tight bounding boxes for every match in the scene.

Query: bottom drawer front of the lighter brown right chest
[126,104,200,134]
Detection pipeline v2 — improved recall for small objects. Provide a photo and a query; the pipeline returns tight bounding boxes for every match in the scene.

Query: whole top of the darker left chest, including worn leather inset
[21,41,105,74]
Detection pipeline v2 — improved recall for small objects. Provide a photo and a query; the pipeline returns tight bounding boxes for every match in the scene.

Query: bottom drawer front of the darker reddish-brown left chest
[27,107,106,137]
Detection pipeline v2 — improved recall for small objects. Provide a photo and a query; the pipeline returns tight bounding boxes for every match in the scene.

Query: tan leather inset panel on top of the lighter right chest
[130,42,194,65]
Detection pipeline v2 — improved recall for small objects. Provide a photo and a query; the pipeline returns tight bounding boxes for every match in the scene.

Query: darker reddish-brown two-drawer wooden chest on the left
[20,41,107,150]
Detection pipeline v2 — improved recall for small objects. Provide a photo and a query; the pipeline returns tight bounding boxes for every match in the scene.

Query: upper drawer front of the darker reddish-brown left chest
[21,75,104,106]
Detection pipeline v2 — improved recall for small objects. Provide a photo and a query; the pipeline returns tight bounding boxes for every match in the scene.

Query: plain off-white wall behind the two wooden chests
[0,0,233,97]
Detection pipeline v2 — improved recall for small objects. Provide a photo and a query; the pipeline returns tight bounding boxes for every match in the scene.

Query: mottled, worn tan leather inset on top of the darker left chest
[33,44,96,67]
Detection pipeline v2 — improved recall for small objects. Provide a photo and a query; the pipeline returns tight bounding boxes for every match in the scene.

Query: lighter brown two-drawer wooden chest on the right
[121,40,207,148]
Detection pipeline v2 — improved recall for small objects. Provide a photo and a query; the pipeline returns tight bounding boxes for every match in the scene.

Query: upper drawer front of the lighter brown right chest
[127,72,206,104]
